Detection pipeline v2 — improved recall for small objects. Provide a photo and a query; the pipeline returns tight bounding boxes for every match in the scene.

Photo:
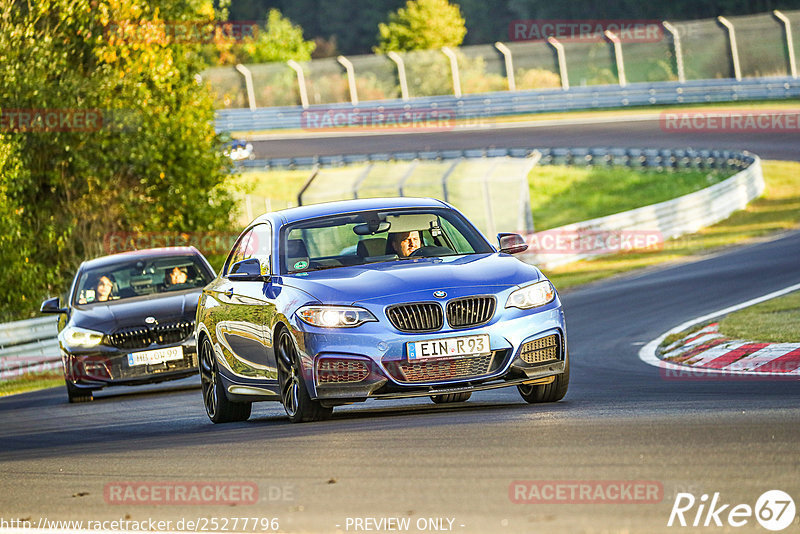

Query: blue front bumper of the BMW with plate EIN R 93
[298,302,567,404]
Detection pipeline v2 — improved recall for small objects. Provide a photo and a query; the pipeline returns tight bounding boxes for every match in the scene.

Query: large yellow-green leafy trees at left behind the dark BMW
[0,0,233,320]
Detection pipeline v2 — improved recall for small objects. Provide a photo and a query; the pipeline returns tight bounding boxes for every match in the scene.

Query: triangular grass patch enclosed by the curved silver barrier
[528,165,732,230]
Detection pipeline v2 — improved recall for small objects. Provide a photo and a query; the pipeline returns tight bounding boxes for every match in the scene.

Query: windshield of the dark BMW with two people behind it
[74,256,213,304]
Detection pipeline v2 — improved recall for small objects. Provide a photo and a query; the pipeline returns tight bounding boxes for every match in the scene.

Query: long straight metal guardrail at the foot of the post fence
[216,77,800,132]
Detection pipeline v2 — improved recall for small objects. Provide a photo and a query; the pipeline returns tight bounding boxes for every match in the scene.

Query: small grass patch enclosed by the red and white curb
[719,291,800,343]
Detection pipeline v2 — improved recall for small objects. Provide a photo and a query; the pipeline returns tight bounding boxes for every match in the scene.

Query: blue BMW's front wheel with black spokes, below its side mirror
[277,329,333,423]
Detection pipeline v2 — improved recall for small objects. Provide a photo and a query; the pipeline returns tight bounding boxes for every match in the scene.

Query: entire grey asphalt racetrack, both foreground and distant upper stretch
[0,119,800,533]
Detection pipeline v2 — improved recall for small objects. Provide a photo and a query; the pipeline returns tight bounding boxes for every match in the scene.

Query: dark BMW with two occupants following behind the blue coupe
[41,247,215,402]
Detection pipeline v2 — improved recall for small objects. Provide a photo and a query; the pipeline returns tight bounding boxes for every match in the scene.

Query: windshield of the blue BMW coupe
[281,209,493,273]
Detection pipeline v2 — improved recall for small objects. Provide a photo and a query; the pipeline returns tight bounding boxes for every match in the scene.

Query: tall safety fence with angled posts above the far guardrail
[201,10,800,113]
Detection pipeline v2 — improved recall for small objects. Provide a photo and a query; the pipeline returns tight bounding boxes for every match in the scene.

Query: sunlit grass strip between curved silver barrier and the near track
[546,161,800,289]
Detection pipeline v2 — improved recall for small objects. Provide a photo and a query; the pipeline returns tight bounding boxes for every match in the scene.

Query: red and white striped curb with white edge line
[639,284,800,377]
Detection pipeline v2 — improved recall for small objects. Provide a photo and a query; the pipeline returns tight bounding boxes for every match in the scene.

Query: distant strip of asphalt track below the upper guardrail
[253,117,800,161]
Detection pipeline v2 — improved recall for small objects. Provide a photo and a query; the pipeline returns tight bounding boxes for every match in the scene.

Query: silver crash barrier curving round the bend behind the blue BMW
[241,147,764,268]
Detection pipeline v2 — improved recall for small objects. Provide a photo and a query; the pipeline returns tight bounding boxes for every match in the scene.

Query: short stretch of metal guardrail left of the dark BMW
[0,316,61,379]
